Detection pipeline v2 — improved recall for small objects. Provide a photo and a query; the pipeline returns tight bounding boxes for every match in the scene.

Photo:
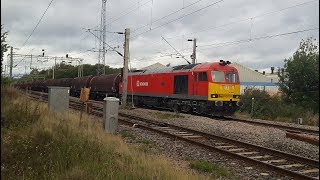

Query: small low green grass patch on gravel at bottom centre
[189,160,235,179]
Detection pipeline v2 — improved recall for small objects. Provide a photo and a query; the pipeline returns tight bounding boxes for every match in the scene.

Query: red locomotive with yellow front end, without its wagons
[120,60,241,115]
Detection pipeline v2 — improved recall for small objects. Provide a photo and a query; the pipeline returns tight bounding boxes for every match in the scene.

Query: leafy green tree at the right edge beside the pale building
[279,38,319,112]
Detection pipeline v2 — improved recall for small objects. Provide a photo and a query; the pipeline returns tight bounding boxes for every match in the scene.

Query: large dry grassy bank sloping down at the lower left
[1,89,210,180]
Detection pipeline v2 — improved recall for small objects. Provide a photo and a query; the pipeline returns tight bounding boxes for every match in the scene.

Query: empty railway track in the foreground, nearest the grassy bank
[23,90,319,179]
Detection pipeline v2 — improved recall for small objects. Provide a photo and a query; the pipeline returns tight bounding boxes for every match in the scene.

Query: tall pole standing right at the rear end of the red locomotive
[121,28,130,107]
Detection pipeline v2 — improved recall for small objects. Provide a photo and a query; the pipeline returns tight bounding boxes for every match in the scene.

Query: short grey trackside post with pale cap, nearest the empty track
[102,97,119,134]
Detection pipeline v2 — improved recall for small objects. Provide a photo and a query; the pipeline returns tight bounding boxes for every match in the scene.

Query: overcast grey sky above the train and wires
[1,0,319,76]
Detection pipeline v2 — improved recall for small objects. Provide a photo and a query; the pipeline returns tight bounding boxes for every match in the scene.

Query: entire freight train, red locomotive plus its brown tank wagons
[16,60,241,115]
